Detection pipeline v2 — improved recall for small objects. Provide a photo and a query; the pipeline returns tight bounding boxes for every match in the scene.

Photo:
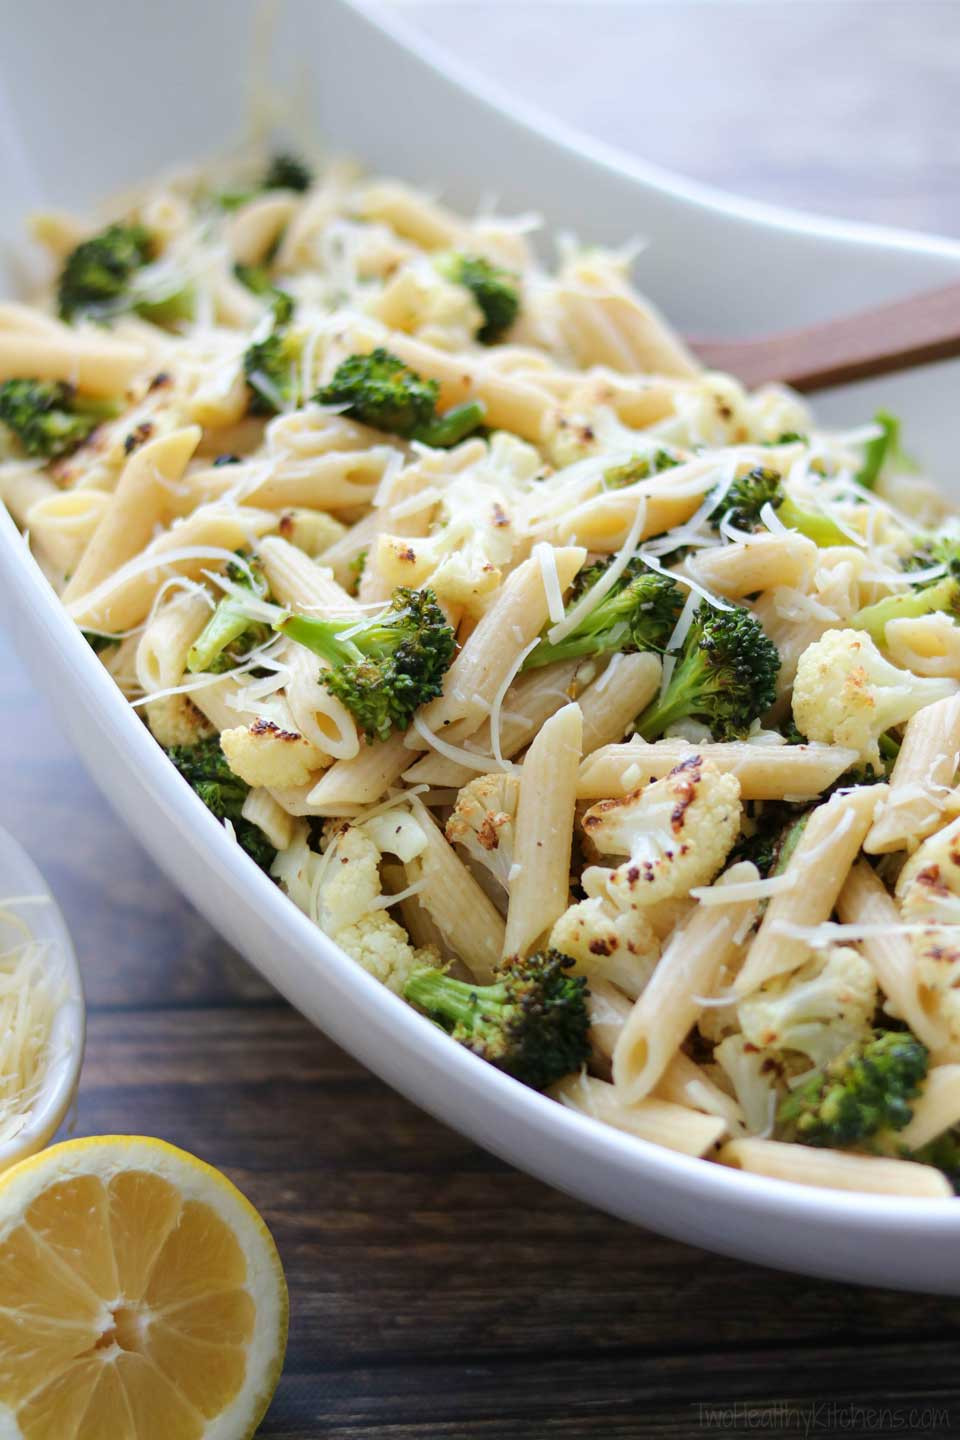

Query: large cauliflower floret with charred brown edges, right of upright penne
[581,755,741,910]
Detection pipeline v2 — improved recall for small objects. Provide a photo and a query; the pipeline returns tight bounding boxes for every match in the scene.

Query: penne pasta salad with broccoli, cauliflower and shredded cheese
[0,154,960,1198]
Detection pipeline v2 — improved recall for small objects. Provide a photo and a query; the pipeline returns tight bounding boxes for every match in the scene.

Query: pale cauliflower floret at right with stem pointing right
[793,629,957,766]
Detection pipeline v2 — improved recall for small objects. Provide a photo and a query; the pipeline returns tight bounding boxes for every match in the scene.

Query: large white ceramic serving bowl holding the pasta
[0,0,960,1293]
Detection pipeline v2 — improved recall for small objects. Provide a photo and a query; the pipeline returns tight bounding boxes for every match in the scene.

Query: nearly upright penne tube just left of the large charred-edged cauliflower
[504,704,583,959]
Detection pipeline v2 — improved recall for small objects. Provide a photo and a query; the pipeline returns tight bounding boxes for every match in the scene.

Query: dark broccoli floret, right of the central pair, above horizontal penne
[636,600,780,740]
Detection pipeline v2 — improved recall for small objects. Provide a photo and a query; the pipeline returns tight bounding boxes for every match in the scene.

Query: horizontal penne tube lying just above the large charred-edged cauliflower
[577,739,856,801]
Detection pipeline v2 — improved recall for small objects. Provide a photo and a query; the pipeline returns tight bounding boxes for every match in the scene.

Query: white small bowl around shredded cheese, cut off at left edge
[0,829,86,1171]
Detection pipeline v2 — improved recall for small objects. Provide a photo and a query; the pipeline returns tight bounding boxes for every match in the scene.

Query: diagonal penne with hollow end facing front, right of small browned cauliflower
[613,861,757,1104]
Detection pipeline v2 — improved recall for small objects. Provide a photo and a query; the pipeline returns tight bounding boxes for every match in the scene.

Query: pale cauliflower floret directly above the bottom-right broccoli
[737,945,878,1066]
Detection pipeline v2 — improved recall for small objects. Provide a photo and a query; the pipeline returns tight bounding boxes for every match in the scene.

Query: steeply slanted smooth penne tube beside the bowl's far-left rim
[63,425,200,605]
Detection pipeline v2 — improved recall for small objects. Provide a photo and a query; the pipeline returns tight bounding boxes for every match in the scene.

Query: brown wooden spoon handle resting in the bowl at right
[688,284,960,392]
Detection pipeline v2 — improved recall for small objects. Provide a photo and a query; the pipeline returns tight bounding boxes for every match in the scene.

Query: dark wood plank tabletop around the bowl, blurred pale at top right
[0,0,960,1440]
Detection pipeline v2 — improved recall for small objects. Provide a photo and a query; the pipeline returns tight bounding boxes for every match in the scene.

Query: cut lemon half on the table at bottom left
[0,1135,288,1440]
